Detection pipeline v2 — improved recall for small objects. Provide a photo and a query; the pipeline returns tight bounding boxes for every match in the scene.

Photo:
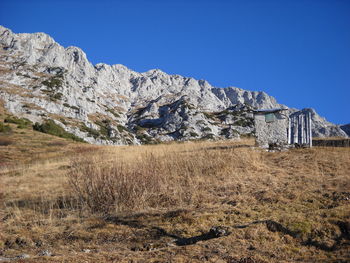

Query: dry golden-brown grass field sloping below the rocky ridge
[0,120,350,263]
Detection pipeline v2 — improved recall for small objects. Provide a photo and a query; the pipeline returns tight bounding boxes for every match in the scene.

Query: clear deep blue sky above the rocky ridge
[0,0,350,124]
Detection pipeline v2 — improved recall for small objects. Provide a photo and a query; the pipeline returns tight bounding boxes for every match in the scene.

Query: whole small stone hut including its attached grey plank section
[254,108,312,148]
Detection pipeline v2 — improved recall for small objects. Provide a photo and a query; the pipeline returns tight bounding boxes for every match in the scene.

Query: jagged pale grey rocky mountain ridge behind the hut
[0,26,346,144]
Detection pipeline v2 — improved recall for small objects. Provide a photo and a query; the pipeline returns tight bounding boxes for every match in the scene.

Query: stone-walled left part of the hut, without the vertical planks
[254,108,289,148]
